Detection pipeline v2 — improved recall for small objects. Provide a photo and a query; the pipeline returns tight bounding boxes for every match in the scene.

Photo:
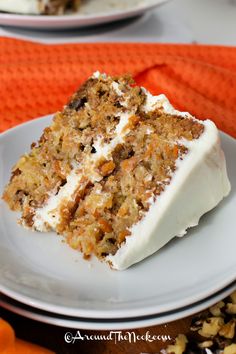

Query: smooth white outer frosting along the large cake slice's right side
[106,94,230,270]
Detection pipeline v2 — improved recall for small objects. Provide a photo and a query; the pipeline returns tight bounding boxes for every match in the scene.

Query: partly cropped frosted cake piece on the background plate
[0,0,80,15]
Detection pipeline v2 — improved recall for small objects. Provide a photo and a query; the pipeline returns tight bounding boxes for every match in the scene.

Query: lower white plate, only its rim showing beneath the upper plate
[0,282,236,330]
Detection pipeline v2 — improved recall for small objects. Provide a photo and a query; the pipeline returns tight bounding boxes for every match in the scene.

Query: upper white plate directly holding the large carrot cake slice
[0,116,236,319]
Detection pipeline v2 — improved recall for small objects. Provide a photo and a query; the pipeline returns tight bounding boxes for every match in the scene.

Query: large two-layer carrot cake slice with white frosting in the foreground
[3,72,230,269]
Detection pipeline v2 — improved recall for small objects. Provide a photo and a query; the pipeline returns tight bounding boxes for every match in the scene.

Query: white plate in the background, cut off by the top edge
[0,0,168,29]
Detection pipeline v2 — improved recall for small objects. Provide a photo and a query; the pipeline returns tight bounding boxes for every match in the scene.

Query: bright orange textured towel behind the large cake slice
[0,38,236,137]
